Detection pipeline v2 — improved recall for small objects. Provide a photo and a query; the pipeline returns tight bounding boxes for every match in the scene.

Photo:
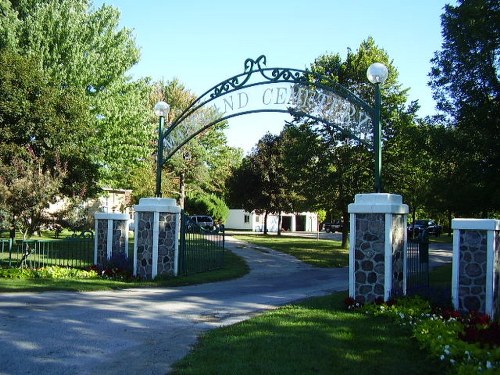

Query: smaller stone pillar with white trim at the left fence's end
[94,212,129,267]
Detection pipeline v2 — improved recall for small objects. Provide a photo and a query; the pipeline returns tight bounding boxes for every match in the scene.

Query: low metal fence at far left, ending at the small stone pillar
[0,238,94,268]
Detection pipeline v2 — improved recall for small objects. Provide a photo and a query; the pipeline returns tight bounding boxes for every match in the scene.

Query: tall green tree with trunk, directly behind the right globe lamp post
[296,38,412,247]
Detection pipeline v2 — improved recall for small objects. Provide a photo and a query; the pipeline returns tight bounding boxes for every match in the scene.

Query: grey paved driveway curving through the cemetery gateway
[0,238,348,375]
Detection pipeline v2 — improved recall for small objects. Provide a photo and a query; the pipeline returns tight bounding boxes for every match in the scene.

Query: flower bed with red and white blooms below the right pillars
[345,296,500,374]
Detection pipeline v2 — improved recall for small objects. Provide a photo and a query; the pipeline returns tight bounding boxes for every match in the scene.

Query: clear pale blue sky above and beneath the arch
[94,0,456,152]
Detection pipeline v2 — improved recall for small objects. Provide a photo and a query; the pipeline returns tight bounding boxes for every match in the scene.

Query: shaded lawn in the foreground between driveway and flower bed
[173,293,444,375]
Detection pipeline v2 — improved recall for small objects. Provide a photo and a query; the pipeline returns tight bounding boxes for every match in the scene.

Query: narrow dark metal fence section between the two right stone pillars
[406,235,429,294]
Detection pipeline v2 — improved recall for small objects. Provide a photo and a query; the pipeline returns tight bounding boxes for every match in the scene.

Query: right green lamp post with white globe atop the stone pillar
[366,63,389,193]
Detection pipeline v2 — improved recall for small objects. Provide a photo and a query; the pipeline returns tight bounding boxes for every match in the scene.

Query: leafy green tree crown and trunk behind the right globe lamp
[287,38,416,247]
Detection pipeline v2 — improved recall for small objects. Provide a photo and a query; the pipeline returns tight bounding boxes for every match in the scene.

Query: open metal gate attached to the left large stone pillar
[179,212,225,275]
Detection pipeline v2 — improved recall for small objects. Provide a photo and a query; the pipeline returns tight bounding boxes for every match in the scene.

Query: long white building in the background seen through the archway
[225,209,318,232]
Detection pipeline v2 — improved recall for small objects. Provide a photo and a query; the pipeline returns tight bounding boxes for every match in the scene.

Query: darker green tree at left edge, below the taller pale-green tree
[0,50,98,195]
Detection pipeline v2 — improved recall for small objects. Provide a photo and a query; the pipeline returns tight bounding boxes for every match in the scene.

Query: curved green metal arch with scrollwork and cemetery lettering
[163,55,373,162]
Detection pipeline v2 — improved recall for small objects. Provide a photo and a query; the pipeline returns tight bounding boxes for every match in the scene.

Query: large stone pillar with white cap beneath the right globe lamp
[348,193,408,303]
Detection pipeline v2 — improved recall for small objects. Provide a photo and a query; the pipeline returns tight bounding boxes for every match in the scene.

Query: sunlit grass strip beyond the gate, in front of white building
[234,234,349,267]
